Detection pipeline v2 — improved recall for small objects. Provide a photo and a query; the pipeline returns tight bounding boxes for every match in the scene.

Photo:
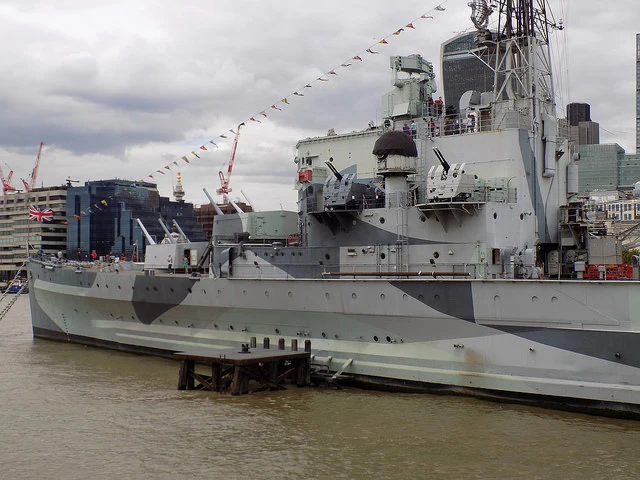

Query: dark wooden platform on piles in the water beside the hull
[174,337,311,395]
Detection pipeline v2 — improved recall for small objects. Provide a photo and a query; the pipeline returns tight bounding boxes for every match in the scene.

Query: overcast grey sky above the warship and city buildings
[0,0,640,209]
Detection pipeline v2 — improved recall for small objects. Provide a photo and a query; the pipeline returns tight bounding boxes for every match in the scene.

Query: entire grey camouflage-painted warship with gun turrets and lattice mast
[28,0,640,417]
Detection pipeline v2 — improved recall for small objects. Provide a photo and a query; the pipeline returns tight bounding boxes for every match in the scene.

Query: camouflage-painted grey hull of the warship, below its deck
[29,263,640,416]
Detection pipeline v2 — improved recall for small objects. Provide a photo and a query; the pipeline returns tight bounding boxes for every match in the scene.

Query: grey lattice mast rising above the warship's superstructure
[469,0,562,243]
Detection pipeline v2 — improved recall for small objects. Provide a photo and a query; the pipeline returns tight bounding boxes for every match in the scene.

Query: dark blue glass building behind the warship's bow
[66,179,206,260]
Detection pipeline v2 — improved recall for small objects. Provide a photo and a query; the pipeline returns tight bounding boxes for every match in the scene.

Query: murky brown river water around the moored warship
[0,295,640,480]
